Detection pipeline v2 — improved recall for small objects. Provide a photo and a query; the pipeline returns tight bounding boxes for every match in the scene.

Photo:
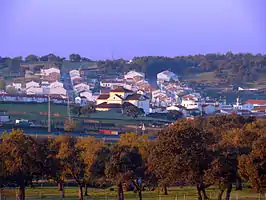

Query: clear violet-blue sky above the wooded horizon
[0,0,266,59]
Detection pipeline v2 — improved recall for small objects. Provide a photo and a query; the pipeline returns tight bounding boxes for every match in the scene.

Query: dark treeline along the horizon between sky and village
[0,52,266,84]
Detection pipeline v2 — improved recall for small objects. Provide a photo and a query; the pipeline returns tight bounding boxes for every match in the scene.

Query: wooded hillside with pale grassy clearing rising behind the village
[0,52,266,86]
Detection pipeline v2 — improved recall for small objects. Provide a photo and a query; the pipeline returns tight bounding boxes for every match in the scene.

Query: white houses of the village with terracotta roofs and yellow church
[0,65,266,117]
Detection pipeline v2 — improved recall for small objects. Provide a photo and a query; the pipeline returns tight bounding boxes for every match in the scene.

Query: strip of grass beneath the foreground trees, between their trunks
[2,187,266,200]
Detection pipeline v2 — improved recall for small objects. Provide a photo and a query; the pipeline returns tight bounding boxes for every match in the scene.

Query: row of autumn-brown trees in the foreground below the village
[0,116,266,200]
